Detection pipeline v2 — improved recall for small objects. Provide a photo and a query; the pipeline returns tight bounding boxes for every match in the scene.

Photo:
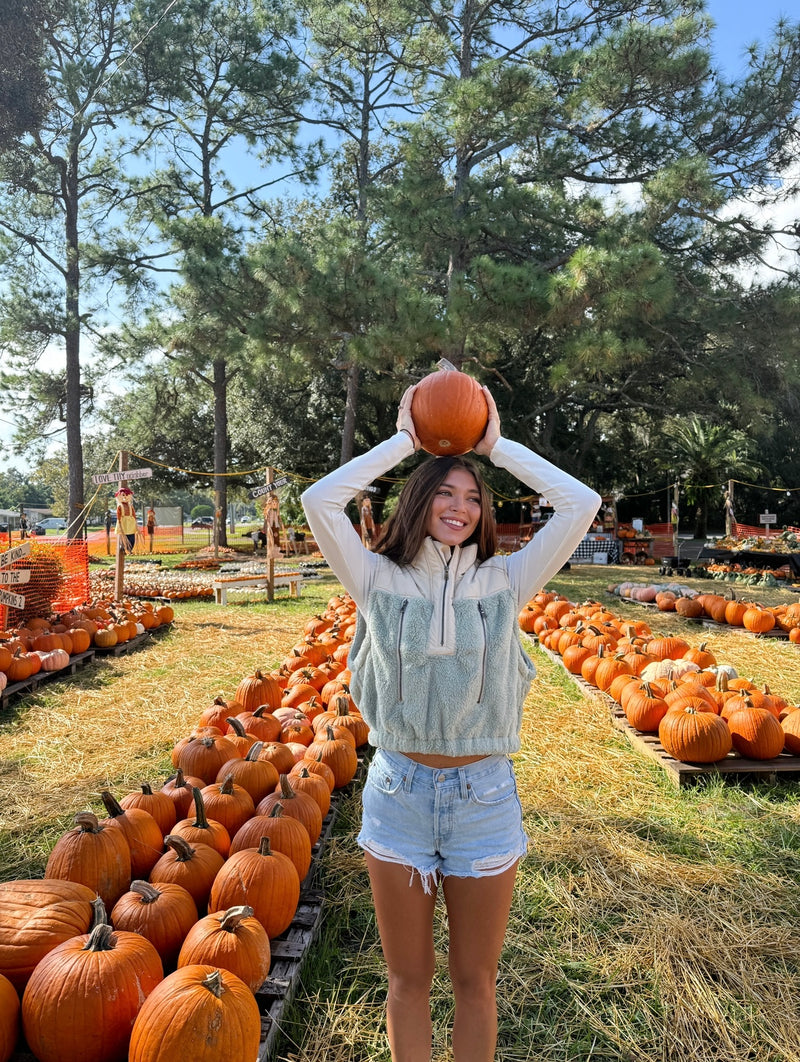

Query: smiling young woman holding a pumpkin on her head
[303,389,599,1062]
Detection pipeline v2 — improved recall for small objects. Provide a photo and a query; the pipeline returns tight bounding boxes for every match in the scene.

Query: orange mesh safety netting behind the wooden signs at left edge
[0,538,90,628]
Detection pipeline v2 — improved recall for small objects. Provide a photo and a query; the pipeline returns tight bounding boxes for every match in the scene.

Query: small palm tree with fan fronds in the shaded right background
[661,414,761,538]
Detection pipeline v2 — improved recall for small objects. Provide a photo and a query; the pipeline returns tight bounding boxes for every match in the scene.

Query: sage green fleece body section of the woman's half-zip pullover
[348,587,537,756]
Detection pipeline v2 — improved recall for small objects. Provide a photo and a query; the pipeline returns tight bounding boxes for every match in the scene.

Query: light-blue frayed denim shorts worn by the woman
[358,749,528,892]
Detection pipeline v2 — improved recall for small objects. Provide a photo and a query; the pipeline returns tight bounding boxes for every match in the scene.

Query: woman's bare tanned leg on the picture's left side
[367,853,436,1062]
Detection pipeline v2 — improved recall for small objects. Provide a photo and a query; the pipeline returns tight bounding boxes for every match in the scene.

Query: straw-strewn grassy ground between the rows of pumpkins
[0,570,800,1062]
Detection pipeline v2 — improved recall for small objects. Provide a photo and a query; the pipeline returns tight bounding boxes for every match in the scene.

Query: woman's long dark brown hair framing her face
[374,457,497,566]
